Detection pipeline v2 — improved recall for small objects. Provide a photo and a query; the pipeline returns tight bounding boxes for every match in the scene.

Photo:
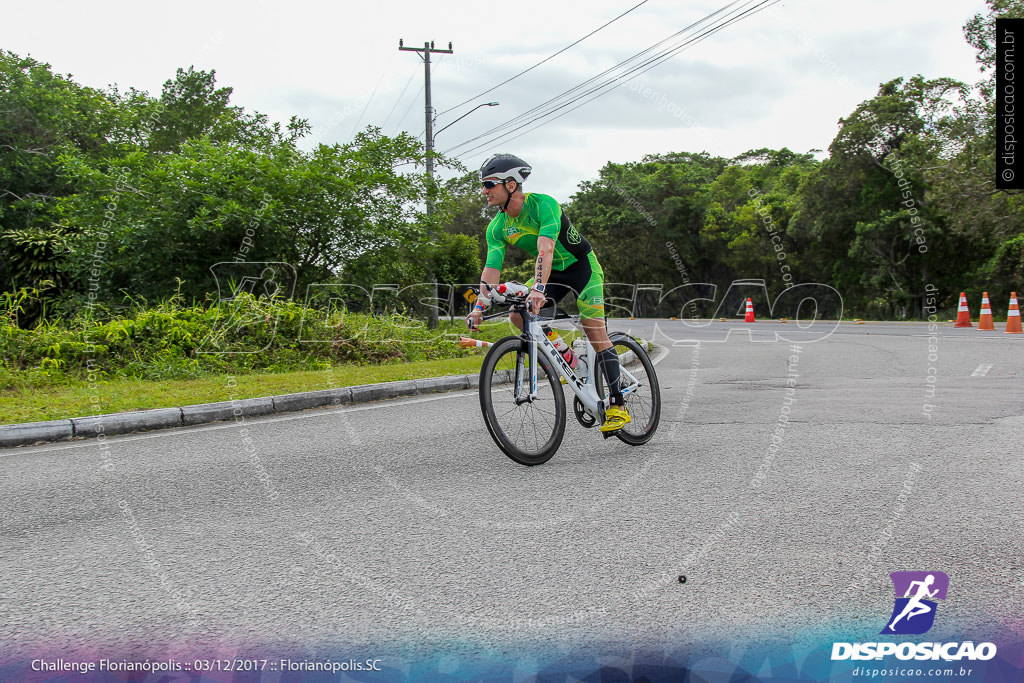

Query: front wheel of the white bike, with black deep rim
[480,337,565,465]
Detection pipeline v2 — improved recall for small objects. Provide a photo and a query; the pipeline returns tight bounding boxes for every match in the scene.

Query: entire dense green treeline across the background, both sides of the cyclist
[0,0,1024,327]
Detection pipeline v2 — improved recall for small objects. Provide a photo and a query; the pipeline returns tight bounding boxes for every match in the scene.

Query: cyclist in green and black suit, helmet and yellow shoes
[467,155,630,432]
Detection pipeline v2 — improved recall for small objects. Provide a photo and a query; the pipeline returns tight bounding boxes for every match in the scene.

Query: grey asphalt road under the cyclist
[0,321,1024,670]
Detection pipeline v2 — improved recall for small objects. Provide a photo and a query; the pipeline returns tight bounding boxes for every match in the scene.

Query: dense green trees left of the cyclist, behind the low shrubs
[0,51,478,325]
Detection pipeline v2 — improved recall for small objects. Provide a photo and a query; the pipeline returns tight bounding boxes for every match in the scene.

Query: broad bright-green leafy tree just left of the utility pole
[60,128,436,301]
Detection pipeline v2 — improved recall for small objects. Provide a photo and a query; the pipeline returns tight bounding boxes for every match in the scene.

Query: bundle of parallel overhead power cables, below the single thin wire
[444,0,779,154]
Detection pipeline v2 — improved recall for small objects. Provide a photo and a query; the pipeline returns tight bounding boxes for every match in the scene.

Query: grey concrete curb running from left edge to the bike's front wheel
[0,375,480,449]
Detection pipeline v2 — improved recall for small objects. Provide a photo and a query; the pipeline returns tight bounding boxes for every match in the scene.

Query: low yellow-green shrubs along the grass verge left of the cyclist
[0,295,520,388]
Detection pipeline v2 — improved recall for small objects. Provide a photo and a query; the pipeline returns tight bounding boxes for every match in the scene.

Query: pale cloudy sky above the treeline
[0,0,985,202]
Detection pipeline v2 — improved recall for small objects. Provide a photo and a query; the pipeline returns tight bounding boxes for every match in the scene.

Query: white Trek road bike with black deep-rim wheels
[480,283,662,465]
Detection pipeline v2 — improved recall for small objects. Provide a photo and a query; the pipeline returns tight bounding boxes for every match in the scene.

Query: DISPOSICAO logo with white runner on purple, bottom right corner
[831,571,996,661]
